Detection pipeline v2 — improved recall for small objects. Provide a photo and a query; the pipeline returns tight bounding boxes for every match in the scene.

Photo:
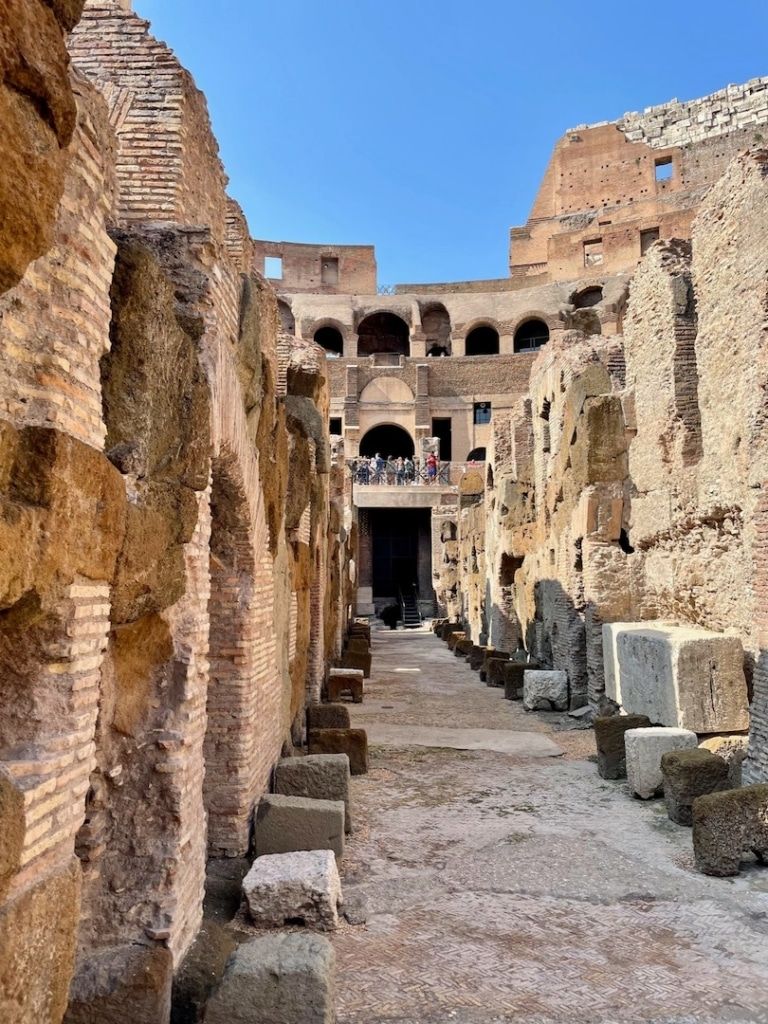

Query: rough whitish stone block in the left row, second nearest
[243,850,341,931]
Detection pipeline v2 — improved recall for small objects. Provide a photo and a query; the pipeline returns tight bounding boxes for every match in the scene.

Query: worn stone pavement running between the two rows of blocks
[334,632,768,1024]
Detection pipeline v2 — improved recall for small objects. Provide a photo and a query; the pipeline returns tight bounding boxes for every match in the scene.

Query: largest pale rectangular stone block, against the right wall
[613,623,750,733]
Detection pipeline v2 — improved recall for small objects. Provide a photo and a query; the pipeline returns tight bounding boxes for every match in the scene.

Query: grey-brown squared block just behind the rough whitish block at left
[255,793,344,859]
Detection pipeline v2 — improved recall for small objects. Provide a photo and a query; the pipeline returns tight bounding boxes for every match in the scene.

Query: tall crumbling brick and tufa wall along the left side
[0,2,352,1024]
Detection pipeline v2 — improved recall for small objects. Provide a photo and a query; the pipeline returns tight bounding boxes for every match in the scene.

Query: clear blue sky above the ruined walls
[134,0,768,284]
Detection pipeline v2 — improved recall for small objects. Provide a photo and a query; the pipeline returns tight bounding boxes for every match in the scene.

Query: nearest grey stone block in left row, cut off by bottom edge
[206,932,336,1024]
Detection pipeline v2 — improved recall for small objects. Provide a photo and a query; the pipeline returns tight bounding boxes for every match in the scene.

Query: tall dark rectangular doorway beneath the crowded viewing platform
[369,509,432,600]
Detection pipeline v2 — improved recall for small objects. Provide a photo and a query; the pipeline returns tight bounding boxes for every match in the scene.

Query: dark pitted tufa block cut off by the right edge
[692,783,768,878]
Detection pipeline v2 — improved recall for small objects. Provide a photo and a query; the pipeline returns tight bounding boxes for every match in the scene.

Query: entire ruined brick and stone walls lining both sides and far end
[0,0,768,1024]
